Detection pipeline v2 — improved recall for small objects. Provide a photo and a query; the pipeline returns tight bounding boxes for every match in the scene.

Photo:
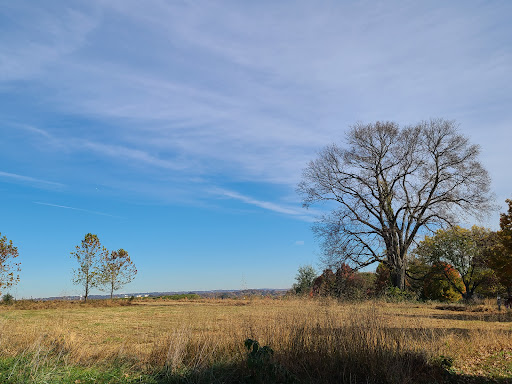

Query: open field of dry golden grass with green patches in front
[0,299,512,383]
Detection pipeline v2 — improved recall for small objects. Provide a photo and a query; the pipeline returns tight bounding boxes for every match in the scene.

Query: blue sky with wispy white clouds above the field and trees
[0,0,512,297]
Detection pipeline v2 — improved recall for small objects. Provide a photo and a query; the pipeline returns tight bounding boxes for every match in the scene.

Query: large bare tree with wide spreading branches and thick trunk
[298,119,492,289]
